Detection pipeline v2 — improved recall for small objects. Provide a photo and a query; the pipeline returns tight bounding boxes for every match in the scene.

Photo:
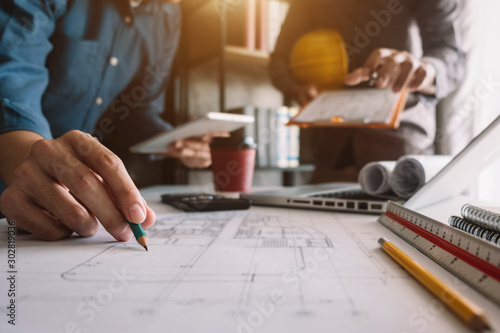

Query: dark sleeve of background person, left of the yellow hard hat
[269,1,317,94]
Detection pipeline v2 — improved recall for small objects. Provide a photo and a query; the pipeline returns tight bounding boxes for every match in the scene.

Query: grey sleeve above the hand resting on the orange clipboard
[413,0,466,99]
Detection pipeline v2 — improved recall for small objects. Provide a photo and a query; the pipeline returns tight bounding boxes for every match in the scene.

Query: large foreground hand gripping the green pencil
[0,131,155,241]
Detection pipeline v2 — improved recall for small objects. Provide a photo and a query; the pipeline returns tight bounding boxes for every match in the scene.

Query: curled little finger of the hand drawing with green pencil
[0,187,73,241]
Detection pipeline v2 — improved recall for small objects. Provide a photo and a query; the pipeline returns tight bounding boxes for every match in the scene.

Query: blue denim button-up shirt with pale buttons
[0,0,180,142]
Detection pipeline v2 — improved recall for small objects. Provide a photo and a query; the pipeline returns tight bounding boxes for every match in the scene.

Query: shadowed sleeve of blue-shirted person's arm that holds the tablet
[105,5,181,147]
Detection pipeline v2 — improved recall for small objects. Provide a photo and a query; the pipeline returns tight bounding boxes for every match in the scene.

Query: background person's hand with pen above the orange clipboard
[344,48,436,94]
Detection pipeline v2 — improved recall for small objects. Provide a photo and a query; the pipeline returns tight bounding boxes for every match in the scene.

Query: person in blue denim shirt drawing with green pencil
[0,0,217,241]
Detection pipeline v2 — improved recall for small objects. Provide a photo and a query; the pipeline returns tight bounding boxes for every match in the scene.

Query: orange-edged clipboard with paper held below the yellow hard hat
[287,88,408,129]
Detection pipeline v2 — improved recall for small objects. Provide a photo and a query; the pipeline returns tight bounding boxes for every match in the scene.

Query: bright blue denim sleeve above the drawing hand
[0,0,66,138]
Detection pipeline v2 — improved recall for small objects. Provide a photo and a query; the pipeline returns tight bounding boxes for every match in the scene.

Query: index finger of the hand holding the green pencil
[61,132,146,223]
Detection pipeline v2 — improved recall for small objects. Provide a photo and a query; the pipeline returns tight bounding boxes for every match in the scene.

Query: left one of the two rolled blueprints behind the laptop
[358,161,396,196]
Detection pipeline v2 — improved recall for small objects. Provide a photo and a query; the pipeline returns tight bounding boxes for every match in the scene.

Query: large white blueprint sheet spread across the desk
[0,187,500,333]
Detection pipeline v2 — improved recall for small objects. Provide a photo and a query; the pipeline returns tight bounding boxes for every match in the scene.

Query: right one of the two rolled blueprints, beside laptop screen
[389,155,452,199]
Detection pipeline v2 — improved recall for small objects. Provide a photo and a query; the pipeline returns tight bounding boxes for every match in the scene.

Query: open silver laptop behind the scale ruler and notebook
[240,116,500,214]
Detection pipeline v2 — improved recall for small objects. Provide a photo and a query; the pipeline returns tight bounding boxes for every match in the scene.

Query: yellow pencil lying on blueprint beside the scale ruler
[378,238,490,330]
